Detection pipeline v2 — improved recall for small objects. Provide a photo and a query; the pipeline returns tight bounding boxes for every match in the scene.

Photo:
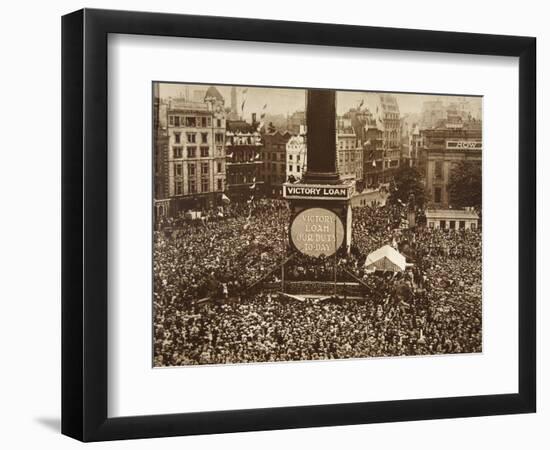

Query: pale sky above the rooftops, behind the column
[159,83,481,117]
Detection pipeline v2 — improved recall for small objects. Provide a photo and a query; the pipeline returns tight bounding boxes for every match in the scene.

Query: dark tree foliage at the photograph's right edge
[447,161,481,211]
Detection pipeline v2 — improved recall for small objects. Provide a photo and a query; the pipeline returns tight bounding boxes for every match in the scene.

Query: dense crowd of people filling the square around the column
[154,199,482,366]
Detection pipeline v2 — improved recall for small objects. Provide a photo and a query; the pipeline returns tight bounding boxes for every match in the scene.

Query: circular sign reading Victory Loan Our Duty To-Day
[290,208,344,257]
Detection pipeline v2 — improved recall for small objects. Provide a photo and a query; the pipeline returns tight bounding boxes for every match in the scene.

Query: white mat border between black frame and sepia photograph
[108,35,518,417]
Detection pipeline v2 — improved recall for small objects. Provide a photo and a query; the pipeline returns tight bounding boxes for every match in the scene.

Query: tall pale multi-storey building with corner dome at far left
[165,87,226,215]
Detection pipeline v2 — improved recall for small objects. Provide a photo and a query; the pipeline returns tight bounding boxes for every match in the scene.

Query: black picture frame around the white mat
[62,9,536,441]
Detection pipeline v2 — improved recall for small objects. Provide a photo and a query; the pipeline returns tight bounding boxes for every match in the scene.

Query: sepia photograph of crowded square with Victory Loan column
[152,82,483,367]
